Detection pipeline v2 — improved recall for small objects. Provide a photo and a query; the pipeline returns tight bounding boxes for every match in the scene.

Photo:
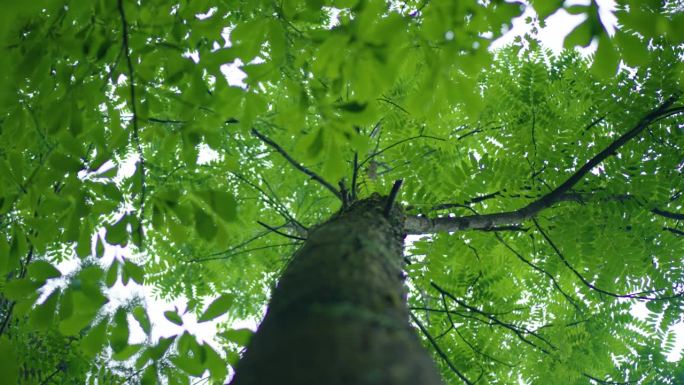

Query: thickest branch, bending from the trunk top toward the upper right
[405,95,679,234]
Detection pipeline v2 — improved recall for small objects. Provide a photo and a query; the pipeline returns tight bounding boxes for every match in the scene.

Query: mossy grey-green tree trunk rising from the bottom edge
[231,196,442,385]
